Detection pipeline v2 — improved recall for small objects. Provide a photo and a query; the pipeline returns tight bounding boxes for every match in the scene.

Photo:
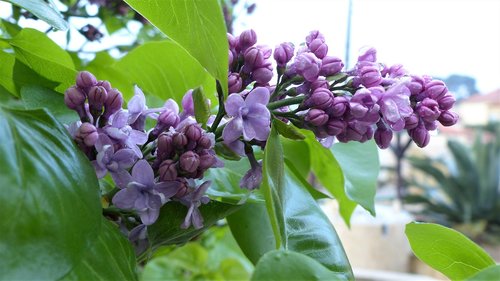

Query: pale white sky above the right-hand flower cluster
[235,0,500,93]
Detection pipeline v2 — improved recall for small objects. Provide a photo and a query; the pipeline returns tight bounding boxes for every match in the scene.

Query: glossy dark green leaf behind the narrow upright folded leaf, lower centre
[228,168,352,278]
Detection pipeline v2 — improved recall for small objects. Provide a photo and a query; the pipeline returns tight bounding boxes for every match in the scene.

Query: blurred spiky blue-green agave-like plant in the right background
[406,138,500,230]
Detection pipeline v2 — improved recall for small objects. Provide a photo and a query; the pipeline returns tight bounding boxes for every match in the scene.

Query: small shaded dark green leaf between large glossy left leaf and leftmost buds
[21,86,80,124]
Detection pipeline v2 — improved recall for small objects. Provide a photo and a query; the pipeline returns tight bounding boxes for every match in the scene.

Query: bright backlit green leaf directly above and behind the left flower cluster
[113,41,216,102]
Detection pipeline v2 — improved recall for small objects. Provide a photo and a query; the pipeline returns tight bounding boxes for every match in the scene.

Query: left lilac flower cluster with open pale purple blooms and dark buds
[64,71,221,235]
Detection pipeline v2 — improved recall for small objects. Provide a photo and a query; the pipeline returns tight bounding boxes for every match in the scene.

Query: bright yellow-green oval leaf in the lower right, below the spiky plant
[405,223,495,280]
